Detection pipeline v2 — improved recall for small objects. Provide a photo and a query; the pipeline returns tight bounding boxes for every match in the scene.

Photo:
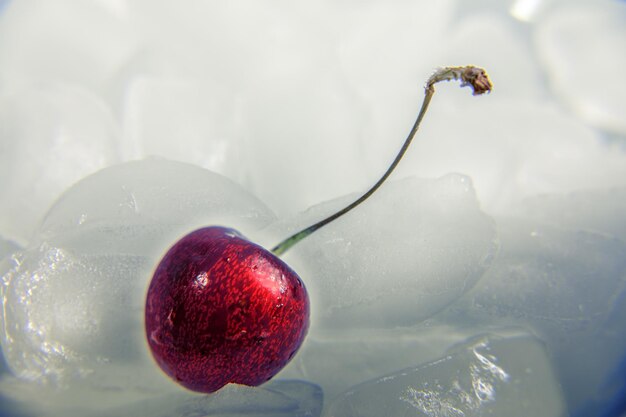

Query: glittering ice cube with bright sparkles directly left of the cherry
[1,247,158,387]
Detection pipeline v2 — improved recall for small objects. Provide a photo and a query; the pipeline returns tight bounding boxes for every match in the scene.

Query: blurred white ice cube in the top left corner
[0,0,138,94]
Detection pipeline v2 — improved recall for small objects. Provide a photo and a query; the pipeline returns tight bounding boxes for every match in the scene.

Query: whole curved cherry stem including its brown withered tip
[272,65,492,256]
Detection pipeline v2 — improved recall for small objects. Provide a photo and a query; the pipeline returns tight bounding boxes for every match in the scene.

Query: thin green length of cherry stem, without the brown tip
[272,83,435,256]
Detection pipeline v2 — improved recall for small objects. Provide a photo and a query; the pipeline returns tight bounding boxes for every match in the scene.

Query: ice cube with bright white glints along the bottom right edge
[324,333,566,417]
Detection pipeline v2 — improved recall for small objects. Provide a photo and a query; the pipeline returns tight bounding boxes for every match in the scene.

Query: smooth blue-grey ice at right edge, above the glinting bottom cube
[440,219,626,410]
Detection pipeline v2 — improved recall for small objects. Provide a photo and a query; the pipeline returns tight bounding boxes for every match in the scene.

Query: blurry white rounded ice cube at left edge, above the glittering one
[0,84,121,243]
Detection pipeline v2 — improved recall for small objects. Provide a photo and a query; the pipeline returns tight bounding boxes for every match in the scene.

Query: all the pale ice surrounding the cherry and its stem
[0,0,626,417]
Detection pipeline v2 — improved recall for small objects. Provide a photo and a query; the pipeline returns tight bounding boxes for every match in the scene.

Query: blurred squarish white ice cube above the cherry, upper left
[114,75,242,177]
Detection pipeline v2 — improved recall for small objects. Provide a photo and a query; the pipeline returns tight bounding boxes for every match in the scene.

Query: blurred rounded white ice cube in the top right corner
[534,0,626,135]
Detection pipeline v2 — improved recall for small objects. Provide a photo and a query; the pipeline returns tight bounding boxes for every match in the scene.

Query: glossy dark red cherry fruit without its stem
[145,227,309,392]
